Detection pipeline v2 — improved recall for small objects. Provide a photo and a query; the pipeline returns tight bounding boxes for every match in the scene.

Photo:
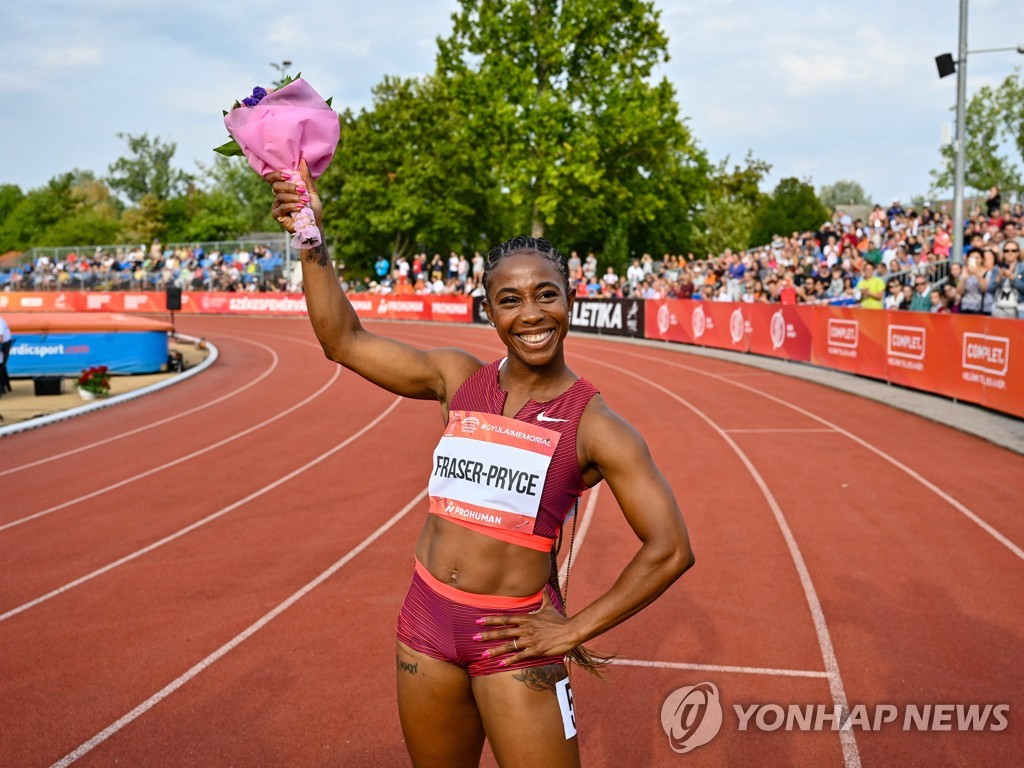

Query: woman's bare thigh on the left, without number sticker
[395,641,483,768]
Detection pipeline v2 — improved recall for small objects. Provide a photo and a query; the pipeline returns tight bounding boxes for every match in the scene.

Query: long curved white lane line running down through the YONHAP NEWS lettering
[577,355,860,768]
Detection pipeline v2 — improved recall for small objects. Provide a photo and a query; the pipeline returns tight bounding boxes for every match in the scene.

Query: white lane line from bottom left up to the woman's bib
[50,487,427,768]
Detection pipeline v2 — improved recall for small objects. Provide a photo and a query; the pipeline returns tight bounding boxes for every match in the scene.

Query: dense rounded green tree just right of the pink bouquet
[318,78,501,268]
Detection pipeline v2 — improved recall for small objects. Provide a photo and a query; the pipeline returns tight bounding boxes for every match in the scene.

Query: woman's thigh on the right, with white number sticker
[473,664,580,768]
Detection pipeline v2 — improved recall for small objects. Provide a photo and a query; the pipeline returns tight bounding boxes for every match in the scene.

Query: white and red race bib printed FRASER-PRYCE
[428,411,561,534]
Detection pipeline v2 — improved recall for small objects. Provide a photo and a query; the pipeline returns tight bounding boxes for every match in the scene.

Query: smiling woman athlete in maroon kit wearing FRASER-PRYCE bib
[266,164,693,766]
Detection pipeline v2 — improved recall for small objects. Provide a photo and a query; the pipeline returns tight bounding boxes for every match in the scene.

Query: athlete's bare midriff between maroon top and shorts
[416,514,551,597]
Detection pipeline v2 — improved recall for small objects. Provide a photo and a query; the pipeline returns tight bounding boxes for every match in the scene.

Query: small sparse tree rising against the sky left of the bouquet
[106,133,191,205]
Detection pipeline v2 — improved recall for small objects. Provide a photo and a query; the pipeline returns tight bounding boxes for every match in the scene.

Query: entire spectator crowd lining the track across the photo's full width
[0,195,1024,317]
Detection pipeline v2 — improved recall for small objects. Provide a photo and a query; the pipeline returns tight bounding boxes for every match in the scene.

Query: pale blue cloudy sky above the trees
[6,0,1024,203]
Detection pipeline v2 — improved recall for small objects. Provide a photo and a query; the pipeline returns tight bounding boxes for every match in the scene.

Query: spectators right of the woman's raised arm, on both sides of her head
[354,195,1024,316]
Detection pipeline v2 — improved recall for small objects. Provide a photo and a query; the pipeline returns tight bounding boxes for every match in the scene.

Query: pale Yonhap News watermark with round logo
[662,683,1010,754]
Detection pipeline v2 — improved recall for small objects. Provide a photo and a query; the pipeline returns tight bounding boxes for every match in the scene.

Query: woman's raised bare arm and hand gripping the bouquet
[266,163,483,403]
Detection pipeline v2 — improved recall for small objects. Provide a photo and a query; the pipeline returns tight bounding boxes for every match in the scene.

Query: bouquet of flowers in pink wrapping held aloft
[216,77,341,248]
